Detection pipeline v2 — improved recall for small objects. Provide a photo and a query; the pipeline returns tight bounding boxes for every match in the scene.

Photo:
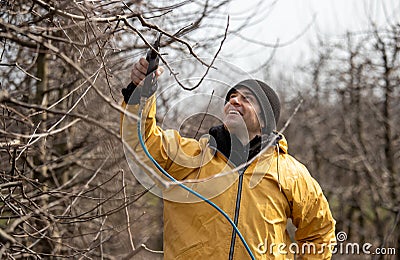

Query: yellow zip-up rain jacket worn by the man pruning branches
[121,96,335,260]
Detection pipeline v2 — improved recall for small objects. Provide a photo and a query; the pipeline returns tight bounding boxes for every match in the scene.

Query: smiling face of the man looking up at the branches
[224,87,263,140]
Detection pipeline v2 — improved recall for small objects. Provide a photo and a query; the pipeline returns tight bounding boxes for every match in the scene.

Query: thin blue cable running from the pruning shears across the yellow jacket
[137,98,255,260]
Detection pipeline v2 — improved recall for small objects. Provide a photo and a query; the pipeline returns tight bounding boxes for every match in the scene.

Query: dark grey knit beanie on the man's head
[225,79,281,134]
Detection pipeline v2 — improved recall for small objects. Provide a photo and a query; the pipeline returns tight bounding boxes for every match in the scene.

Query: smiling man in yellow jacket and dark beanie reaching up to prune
[121,58,335,259]
